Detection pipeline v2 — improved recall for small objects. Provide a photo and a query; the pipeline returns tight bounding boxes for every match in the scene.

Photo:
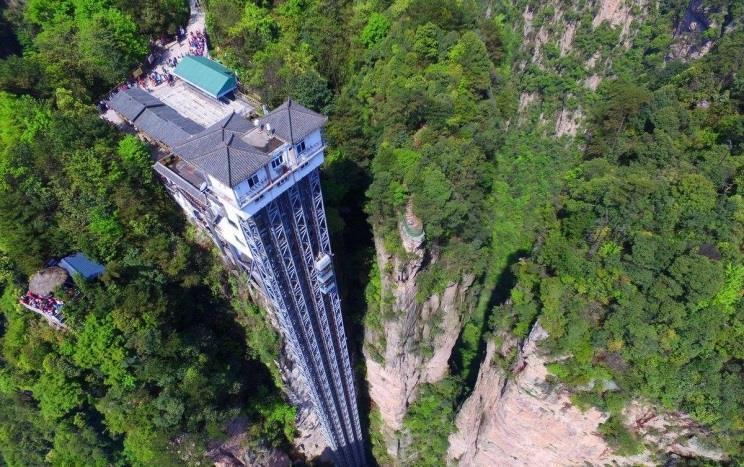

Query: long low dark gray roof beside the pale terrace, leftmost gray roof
[110,87,204,147]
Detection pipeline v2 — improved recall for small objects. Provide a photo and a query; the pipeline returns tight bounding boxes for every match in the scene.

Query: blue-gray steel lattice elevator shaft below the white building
[241,169,364,465]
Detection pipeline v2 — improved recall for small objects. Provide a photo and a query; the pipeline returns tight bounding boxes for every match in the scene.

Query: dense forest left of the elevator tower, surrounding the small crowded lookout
[0,1,294,466]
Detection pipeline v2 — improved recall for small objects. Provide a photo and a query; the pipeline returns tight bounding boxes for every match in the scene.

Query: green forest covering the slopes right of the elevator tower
[215,0,744,464]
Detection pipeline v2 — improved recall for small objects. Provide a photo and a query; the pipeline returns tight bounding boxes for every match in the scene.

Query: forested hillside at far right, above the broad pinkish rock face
[494,34,744,456]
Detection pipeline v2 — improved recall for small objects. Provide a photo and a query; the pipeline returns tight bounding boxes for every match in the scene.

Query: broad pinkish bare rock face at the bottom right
[448,325,723,466]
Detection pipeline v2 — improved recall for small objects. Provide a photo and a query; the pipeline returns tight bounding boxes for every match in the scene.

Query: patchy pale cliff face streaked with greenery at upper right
[515,0,647,136]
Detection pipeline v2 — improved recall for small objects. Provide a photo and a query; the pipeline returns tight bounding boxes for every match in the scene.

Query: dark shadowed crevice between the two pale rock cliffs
[449,250,529,405]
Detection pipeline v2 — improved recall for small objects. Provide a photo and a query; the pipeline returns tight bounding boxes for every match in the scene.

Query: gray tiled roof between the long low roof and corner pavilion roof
[173,113,271,187]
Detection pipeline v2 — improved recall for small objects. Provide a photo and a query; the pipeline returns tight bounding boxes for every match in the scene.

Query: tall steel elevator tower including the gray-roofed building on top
[110,88,366,466]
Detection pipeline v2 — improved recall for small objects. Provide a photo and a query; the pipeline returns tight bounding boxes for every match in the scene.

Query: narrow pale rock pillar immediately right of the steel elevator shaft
[364,225,473,456]
